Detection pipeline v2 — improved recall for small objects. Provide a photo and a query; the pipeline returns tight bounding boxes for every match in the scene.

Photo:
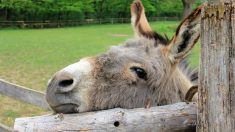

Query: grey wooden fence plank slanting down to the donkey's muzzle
[0,79,49,109]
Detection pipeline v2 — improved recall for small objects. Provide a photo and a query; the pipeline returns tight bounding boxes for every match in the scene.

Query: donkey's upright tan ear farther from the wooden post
[131,0,167,44]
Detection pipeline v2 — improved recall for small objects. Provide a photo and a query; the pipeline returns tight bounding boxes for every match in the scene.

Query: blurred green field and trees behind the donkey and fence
[0,0,202,127]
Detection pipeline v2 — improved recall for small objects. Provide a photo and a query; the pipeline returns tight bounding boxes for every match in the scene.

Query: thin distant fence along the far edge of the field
[0,17,180,28]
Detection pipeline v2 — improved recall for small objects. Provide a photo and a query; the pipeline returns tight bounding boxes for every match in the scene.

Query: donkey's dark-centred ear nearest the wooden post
[168,5,203,61]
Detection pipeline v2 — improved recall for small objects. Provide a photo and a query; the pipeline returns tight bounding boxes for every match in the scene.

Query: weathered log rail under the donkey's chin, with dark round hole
[14,103,197,132]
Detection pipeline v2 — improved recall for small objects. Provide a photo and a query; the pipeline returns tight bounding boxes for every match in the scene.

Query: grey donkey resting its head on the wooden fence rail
[46,0,202,113]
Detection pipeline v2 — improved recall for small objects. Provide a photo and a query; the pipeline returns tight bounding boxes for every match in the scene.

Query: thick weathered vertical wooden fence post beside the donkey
[197,0,235,132]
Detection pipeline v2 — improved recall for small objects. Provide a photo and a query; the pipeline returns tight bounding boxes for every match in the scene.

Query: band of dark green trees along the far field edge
[0,0,202,21]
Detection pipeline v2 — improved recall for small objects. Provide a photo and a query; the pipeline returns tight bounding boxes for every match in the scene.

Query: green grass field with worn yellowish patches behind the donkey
[0,21,199,126]
